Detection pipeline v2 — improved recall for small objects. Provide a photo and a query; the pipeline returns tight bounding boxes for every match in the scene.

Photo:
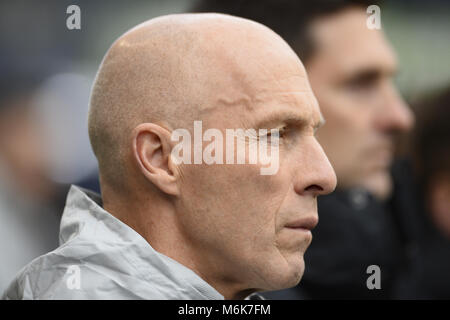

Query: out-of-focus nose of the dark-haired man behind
[377,85,414,132]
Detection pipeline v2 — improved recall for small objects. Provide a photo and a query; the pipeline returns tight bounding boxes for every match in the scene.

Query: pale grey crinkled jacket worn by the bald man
[3,186,223,299]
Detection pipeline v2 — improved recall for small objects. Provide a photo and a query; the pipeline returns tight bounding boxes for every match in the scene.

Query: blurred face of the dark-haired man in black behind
[306,8,413,198]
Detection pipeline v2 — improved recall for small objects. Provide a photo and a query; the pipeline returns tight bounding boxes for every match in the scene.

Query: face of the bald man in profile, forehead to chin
[174,45,336,298]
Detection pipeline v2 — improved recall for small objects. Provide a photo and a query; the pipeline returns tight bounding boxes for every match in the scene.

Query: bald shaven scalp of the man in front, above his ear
[89,14,301,187]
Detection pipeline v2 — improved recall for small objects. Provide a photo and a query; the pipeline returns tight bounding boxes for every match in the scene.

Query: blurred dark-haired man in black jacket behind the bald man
[192,0,413,299]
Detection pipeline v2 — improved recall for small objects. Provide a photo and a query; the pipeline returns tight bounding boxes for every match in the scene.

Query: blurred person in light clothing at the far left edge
[0,60,67,291]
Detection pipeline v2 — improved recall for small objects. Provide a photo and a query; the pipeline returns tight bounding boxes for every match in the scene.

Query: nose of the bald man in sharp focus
[294,137,337,196]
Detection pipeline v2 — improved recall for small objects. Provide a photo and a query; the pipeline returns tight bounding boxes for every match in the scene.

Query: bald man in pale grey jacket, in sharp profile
[4,14,336,299]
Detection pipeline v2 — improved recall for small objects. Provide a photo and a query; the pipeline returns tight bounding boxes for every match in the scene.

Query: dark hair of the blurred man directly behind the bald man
[191,0,375,63]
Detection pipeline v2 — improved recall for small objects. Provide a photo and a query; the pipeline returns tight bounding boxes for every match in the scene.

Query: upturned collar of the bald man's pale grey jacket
[60,186,224,299]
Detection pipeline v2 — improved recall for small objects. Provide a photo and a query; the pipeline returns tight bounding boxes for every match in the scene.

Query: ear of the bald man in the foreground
[132,123,179,195]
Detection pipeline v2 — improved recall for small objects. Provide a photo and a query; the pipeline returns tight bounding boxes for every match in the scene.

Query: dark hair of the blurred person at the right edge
[411,87,450,188]
